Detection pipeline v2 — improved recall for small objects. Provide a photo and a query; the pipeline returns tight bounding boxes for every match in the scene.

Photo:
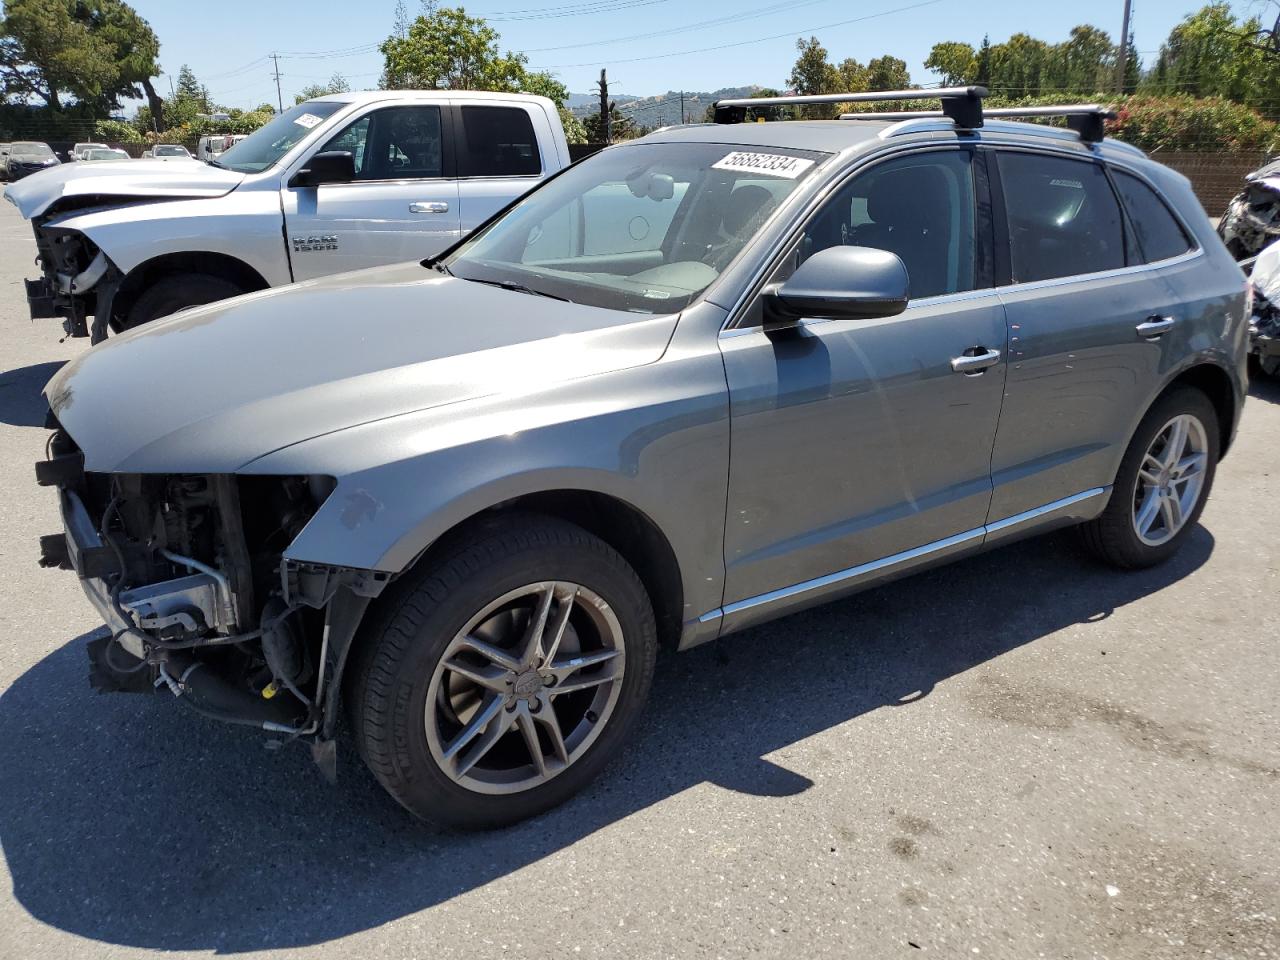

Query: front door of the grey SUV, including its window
[721,147,1007,628]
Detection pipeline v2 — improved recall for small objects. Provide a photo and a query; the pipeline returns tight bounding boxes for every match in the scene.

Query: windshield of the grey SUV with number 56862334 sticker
[442,143,827,314]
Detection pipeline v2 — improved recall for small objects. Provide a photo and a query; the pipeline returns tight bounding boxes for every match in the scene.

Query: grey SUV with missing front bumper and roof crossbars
[37,90,1247,826]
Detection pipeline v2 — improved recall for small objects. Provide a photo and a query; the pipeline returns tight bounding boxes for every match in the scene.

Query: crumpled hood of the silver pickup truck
[4,160,244,220]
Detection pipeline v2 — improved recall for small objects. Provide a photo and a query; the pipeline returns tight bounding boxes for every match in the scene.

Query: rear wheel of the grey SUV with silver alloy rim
[1082,387,1221,570]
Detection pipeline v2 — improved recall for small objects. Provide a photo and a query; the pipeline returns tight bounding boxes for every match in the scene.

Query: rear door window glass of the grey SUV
[998,152,1125,283]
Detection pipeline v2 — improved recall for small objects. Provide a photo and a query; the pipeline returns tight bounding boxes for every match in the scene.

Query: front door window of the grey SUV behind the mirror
[800,150,977,300]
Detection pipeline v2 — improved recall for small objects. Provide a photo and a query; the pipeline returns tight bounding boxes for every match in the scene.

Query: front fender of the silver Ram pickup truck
[46,189,293,287]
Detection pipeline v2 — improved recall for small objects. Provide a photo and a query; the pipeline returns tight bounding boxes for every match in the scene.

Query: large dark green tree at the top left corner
[0,0,160,116]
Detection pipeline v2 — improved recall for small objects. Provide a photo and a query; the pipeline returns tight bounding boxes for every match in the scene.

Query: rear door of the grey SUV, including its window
[991,150,1184,524]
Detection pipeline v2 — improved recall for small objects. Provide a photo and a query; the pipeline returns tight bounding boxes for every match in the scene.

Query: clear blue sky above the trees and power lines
[132,0,1218,106]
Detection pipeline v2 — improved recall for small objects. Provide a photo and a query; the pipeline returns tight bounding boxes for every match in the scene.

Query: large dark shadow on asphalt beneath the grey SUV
[0,527,1213,954]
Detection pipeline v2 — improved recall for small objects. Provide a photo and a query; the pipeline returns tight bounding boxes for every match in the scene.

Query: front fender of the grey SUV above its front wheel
[241,343,728,632]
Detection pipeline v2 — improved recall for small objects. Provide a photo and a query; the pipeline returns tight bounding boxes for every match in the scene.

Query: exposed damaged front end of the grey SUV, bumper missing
[36,430,387,777]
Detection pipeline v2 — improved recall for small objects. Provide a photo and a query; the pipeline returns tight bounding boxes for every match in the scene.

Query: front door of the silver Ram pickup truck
[282,104,460,280]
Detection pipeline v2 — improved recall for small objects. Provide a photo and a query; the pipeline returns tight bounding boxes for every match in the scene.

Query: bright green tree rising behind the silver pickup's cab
[379,5,568,106]
